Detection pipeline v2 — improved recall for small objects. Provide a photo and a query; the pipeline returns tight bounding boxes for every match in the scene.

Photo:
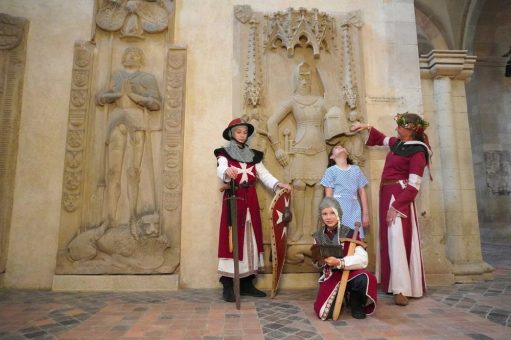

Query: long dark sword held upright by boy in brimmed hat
[227,179,240,310]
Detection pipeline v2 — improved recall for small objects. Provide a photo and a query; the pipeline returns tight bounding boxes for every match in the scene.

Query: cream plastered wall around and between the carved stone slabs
[0,0,496,290]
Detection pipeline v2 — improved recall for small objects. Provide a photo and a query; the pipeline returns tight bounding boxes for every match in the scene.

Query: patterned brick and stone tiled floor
[0,240,511,340]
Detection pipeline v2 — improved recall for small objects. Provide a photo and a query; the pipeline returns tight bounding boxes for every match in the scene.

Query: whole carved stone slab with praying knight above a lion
[56,0,186,275]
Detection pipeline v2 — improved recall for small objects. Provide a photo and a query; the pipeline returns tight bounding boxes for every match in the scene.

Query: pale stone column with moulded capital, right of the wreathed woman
[421,50,493,282]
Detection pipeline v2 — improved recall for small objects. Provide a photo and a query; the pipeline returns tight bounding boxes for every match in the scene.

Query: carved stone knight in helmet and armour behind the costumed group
[267,62,340,242]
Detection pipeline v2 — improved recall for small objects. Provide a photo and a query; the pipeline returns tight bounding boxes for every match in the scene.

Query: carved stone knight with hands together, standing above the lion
[96,47,161,239]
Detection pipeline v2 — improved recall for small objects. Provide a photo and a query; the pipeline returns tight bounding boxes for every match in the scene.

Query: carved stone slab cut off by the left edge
[0,13,29,273]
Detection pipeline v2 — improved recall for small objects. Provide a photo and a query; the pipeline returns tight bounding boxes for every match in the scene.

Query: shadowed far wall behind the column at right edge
[467,1,511,242]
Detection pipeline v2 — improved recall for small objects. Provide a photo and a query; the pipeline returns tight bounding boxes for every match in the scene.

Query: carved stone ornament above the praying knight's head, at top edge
[96,0,174,39]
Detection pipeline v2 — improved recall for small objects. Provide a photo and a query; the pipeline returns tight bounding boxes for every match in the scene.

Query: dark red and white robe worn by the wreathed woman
[366,128,429,297]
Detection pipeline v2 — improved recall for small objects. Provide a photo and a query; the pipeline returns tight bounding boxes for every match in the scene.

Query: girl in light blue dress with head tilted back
[321,144,369,239]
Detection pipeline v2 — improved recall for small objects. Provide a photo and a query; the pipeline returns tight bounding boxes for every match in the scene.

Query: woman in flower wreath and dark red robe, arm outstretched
[351,113,432,306]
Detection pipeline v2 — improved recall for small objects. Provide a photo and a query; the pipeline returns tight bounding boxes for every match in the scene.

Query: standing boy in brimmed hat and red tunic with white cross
[214,118,291,302]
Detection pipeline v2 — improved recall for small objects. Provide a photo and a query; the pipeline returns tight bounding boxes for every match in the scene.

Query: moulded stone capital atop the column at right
[419,50,477,81]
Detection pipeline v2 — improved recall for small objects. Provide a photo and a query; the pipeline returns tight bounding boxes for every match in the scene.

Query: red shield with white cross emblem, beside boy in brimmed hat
[270,189,292,298]
